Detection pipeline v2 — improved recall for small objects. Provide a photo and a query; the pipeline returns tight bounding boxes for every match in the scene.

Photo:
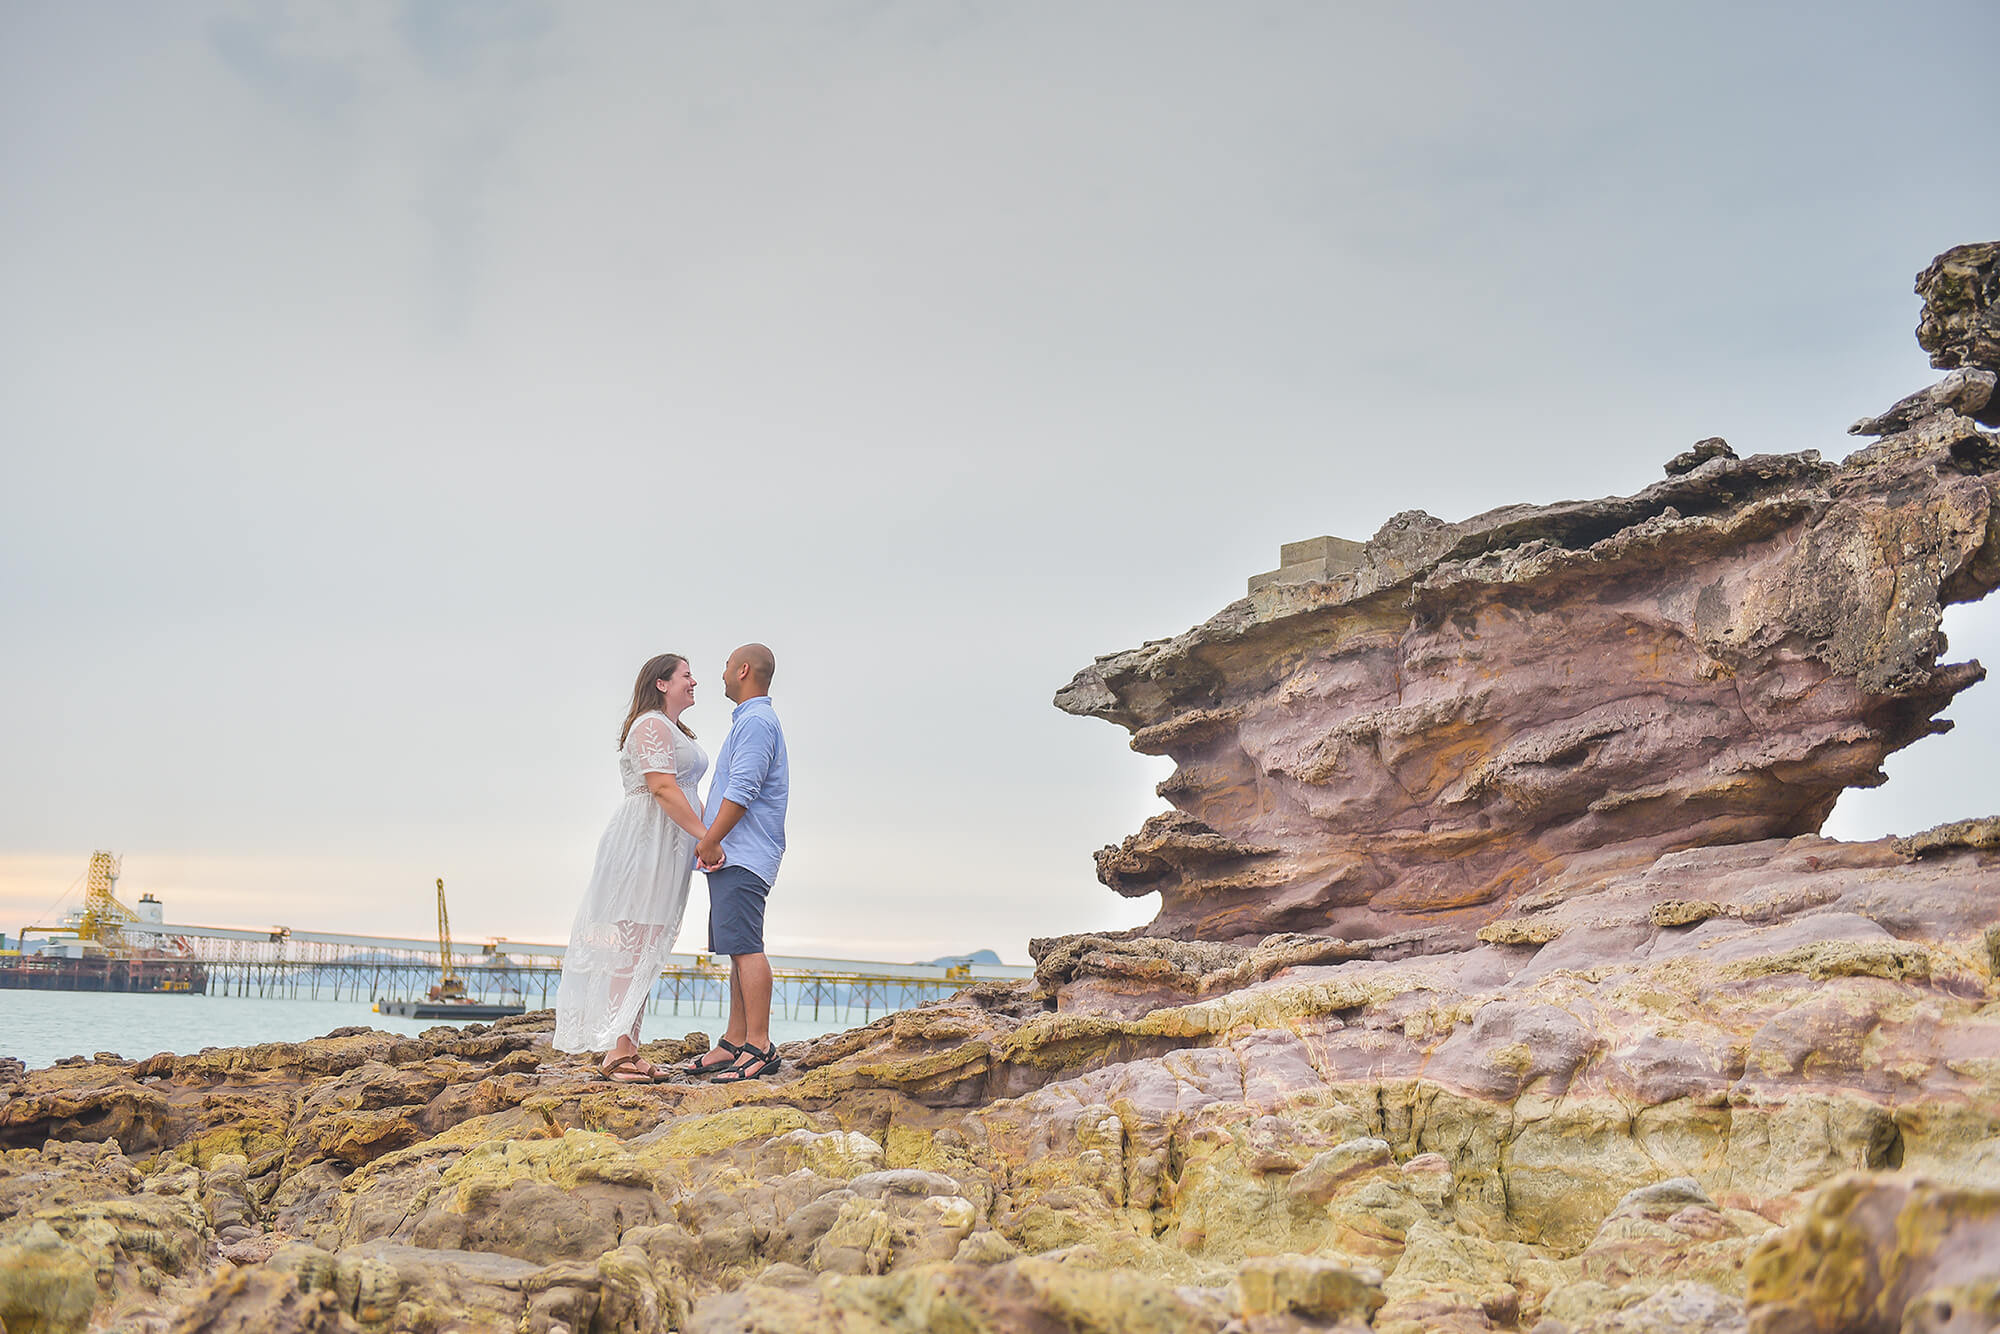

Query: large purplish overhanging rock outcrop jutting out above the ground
[1056,268,2000,940]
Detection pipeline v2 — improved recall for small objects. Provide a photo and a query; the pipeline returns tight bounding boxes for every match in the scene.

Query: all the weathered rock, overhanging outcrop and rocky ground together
[0,252,2000,1334]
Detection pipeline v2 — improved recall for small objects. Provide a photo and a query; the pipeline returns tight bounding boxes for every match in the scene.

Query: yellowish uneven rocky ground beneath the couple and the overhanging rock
[0,850,2000,1334]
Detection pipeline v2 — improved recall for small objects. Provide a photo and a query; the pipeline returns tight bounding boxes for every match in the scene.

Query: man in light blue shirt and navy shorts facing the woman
[688,644,792,1084]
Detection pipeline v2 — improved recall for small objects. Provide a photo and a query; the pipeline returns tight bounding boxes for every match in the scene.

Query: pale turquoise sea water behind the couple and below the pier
[0,990,884,1068]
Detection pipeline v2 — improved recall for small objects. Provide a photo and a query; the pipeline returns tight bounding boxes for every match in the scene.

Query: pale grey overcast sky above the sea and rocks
[0,0,2000,962]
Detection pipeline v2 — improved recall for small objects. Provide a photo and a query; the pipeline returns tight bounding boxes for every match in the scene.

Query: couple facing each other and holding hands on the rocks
[556,644,792,1084]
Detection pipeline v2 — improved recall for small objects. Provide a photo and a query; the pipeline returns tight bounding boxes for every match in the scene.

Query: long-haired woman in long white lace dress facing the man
[556,654,708,1084]
